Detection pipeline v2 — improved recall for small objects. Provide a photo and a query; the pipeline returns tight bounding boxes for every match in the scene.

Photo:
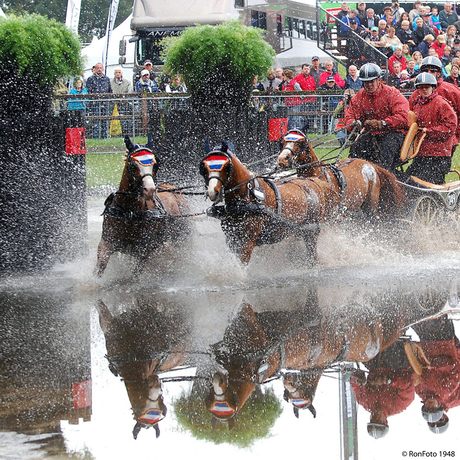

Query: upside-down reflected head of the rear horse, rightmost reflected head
[283,369,322,418]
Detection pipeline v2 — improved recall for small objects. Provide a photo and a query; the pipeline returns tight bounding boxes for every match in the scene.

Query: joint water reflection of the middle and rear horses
[206,289,448,428]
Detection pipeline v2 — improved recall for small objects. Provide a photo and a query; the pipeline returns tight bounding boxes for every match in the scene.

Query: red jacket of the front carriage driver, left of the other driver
[345,83,409,134]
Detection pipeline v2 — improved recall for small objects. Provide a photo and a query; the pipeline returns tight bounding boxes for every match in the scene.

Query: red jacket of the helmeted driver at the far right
[409,91,457,157]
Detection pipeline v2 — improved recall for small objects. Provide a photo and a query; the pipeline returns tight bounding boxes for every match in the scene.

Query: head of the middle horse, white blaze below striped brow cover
[200,142,233,203]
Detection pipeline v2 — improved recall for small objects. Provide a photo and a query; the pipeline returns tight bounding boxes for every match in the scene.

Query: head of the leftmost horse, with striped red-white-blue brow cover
[125,136,158,200]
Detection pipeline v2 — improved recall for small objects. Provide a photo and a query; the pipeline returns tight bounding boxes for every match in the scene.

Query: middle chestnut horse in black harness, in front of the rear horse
[200,143,339,264]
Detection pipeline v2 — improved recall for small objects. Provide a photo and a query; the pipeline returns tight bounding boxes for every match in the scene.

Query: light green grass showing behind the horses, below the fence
[86,137,460,187]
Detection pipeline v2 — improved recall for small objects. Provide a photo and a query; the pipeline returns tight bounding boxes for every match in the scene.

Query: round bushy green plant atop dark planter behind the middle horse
[164,21,275,109]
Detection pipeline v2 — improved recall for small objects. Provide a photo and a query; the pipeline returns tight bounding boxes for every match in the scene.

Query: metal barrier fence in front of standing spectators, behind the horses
[56,92,414,142]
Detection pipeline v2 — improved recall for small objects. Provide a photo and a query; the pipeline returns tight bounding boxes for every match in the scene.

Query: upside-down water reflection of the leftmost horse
[96,299,189,439]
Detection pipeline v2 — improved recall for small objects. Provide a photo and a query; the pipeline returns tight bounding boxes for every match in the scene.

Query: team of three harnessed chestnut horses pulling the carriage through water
[94,130,403,276]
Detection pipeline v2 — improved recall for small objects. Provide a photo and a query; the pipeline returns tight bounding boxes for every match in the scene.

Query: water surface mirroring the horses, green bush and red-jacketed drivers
[0,270,460,459]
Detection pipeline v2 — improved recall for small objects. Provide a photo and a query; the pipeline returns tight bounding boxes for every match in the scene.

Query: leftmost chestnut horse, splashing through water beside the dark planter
[94,136,190,276]
